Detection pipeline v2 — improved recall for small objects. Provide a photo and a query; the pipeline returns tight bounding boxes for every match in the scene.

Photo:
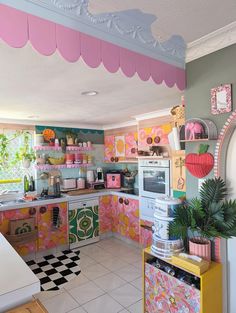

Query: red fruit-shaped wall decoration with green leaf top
[185,144,214,178]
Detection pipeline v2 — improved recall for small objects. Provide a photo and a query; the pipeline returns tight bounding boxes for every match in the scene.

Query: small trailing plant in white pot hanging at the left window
[14,132,36,168]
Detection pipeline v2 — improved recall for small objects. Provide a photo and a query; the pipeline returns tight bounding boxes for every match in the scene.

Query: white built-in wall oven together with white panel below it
[139,159,170,222]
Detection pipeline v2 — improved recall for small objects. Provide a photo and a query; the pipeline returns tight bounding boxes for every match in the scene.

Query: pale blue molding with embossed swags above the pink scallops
[0,0,186,68]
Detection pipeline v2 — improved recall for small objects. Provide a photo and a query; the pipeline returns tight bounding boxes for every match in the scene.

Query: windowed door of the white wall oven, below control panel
[139,167,170,198]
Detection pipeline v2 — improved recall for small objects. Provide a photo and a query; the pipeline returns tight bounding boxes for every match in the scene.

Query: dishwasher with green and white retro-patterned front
[68,197,99,249]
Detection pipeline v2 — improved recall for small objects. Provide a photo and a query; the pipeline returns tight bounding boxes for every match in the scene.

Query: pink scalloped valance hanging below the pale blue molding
[0,4,185,90]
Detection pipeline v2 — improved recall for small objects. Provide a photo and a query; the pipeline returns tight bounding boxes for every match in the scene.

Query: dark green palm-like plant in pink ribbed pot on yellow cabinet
[170,178,236,260]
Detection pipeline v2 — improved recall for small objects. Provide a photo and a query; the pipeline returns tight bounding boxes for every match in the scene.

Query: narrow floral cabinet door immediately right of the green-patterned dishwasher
[98,196,112,234]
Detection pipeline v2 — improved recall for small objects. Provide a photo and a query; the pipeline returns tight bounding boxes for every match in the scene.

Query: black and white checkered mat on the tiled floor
[26,250,81,291]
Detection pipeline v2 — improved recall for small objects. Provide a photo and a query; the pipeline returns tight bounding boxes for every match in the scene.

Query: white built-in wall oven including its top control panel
[139,159,170,199]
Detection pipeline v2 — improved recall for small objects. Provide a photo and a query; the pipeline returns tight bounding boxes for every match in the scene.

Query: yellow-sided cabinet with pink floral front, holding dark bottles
[143,248,222,313]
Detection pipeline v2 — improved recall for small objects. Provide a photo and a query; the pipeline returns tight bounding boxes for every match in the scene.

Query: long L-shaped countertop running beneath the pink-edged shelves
[0,189,139,212]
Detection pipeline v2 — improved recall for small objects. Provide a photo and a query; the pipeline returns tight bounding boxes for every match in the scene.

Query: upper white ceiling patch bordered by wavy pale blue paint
[89,0,236,43]
